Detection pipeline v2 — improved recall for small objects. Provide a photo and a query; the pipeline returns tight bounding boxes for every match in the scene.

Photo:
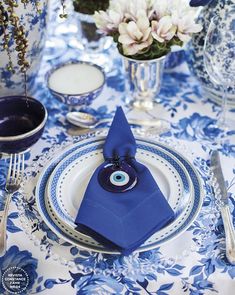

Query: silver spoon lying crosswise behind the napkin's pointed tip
[66,112,169,129]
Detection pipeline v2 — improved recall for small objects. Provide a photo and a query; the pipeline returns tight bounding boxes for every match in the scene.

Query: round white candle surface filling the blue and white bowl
[48,63,105,95]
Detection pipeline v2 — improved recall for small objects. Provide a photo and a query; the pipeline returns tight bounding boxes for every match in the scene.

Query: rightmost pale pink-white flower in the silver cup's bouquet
[172,11,202,42]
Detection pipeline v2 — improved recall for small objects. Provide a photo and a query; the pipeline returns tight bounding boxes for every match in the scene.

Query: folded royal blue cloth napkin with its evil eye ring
[75,107,174,255]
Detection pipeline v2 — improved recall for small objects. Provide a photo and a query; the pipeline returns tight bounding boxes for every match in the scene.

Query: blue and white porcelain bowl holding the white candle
[46,61,106,107]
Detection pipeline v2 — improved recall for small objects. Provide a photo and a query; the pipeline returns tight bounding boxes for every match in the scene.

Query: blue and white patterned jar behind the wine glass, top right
[186,0,235,105]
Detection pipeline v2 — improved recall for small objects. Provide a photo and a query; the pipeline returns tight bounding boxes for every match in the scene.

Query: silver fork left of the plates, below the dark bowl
[0,153,24,256]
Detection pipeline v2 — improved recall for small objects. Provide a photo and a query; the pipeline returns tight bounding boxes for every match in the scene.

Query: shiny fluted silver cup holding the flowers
[123,56,166,110]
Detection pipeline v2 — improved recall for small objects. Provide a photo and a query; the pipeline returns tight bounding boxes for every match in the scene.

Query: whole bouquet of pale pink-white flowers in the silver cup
[94,0,202,60]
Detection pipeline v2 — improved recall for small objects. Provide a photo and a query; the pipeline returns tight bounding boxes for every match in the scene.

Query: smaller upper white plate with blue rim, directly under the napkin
[46,141,190,229]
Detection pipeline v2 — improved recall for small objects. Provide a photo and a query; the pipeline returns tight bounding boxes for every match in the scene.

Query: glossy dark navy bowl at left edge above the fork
[0,96,47,154]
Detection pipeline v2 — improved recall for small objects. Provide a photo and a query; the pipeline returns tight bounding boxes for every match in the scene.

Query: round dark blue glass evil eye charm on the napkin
[98,161,137,193]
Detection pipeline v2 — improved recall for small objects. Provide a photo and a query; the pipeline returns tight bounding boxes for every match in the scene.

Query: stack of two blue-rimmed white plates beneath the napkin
[36,137,203,254]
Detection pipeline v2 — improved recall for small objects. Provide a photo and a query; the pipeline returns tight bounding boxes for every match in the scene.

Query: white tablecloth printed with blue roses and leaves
[0,5,235,295]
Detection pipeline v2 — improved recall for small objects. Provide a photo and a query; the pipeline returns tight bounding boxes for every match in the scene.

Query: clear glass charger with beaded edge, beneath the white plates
[16,130,218,273]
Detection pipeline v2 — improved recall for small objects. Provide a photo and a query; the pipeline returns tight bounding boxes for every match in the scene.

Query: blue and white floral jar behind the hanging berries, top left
[0,0,48,96]
